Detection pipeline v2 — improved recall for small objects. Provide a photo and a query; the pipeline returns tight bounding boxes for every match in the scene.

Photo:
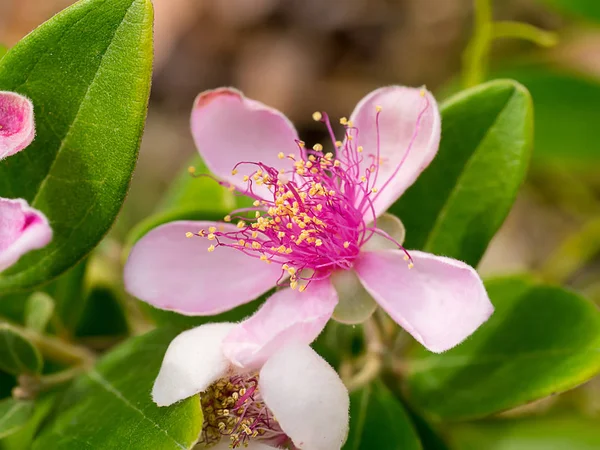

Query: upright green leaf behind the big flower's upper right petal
[390,80,533,265]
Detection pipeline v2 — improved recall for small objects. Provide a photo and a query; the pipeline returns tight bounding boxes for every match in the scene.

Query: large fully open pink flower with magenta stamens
[125,86,493,367]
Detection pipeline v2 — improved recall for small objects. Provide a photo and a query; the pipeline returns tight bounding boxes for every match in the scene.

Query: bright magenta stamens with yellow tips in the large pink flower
[187,95,429,291]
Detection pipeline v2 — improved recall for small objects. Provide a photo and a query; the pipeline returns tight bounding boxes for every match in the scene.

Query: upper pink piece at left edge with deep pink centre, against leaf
[0,92,35,160]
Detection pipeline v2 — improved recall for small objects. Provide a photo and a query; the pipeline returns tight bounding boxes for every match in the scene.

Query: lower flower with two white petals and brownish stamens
[152,323,350,450]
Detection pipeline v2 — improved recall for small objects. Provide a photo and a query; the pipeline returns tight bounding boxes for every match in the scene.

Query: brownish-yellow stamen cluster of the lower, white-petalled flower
[199,373,295,449]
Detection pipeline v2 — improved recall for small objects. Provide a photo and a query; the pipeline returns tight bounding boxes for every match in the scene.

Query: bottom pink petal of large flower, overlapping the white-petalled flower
[223,280,338,369]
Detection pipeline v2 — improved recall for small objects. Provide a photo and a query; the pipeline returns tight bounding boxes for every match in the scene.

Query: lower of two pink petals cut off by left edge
[0,198,52,272]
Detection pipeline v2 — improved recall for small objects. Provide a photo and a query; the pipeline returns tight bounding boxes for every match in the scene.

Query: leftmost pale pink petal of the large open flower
[124,221,281,316]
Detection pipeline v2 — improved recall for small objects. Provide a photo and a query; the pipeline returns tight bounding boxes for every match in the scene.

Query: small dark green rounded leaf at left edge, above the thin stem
[0,323,43,375]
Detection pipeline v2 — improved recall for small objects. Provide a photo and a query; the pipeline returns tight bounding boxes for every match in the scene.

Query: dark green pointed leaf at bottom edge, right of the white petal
[343,380,422,450]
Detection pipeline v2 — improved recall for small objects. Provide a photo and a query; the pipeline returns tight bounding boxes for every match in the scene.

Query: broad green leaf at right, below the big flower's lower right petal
[406,277,600,420]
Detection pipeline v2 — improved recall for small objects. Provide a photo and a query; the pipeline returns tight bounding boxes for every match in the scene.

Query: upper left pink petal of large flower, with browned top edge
[191,88,298,197]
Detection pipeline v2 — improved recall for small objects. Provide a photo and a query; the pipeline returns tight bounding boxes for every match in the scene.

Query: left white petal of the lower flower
[152,323,234,406]
